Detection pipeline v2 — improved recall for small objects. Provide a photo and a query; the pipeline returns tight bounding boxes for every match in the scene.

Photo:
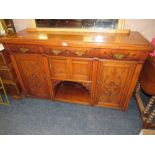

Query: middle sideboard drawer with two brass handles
[41,46,93,58]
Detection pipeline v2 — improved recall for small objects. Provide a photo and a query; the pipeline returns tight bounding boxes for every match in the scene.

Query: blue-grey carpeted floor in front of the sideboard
[0,92,149,135]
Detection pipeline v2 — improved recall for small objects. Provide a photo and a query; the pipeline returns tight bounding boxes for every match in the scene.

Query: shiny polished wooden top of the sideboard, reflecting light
[0,29,153,51]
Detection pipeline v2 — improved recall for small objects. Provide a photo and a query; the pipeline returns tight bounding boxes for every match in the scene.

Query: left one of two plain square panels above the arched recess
[49,57,68,80]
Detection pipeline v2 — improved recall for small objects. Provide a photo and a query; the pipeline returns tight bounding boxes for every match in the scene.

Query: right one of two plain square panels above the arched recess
[70,58,92,81]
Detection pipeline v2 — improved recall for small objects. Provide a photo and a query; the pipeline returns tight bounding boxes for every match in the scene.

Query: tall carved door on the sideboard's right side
[97,60,136,109]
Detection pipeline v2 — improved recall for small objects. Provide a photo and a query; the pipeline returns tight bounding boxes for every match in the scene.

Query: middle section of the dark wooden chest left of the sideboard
[0,64,16,80]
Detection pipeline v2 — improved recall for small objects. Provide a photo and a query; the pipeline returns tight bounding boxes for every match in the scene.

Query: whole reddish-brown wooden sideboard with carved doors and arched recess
[0,30,153,110]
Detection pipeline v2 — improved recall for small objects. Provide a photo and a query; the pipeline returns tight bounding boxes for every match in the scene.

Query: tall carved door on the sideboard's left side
[12,54,50,98]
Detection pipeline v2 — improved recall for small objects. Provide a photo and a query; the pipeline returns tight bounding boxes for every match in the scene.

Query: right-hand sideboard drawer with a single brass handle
[93,49,147,61]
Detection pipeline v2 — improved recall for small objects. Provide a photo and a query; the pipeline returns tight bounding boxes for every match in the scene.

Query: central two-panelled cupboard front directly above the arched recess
[49,57,92,82]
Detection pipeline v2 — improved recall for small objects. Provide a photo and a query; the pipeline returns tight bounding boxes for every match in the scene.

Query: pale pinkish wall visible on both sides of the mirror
[13,19,155,41]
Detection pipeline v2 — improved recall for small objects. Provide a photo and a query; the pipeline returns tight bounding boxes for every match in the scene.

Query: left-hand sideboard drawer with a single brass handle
[5,44,40,53]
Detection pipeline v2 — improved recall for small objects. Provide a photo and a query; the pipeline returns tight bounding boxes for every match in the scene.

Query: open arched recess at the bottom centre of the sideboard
[54,81,91,105]
